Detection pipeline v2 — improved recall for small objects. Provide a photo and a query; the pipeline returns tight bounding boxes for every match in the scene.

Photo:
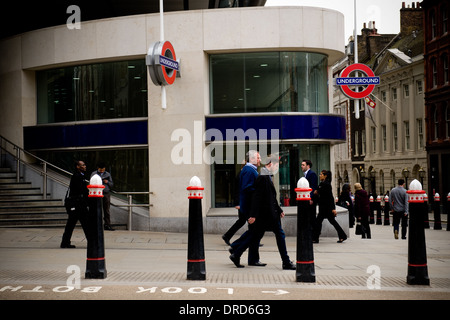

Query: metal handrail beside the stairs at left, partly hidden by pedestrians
[0,135,153,231]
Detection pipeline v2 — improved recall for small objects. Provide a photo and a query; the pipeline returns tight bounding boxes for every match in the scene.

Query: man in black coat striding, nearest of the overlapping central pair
[230,155,296,270]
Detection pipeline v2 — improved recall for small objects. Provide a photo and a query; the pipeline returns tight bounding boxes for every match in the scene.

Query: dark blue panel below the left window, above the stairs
[23,120,148,150]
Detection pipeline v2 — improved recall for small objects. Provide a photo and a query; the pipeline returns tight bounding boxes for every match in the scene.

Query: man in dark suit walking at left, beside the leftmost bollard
[61,160,89,248]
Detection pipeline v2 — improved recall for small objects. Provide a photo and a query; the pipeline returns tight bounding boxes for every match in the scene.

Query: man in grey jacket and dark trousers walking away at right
[389,179,408,239]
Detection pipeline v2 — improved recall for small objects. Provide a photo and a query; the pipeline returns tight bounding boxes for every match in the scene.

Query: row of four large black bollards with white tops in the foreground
[78,175,440,285]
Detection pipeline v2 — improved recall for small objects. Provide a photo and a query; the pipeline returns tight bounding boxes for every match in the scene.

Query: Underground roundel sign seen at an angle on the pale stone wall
[146,41,180,86]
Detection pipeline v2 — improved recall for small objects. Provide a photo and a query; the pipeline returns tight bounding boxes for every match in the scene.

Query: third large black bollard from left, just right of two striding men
[295,177,316,282]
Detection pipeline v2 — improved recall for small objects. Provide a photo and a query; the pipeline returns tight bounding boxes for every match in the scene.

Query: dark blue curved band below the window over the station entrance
[205,114,346,141]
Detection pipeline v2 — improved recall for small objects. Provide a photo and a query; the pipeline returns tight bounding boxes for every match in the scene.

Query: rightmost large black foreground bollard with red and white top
[406,180,430,285]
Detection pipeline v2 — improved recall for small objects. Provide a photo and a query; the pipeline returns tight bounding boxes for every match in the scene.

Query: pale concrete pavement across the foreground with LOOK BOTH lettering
[0,221,450,300]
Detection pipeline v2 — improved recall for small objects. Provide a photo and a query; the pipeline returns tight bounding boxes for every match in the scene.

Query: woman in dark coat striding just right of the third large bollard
[313,170,347,243]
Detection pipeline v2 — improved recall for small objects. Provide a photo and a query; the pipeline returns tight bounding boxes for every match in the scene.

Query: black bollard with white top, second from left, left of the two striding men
[187,176,206,280]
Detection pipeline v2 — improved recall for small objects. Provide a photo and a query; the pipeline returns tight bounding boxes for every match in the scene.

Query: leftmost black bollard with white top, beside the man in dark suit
[85,174,106,279]
